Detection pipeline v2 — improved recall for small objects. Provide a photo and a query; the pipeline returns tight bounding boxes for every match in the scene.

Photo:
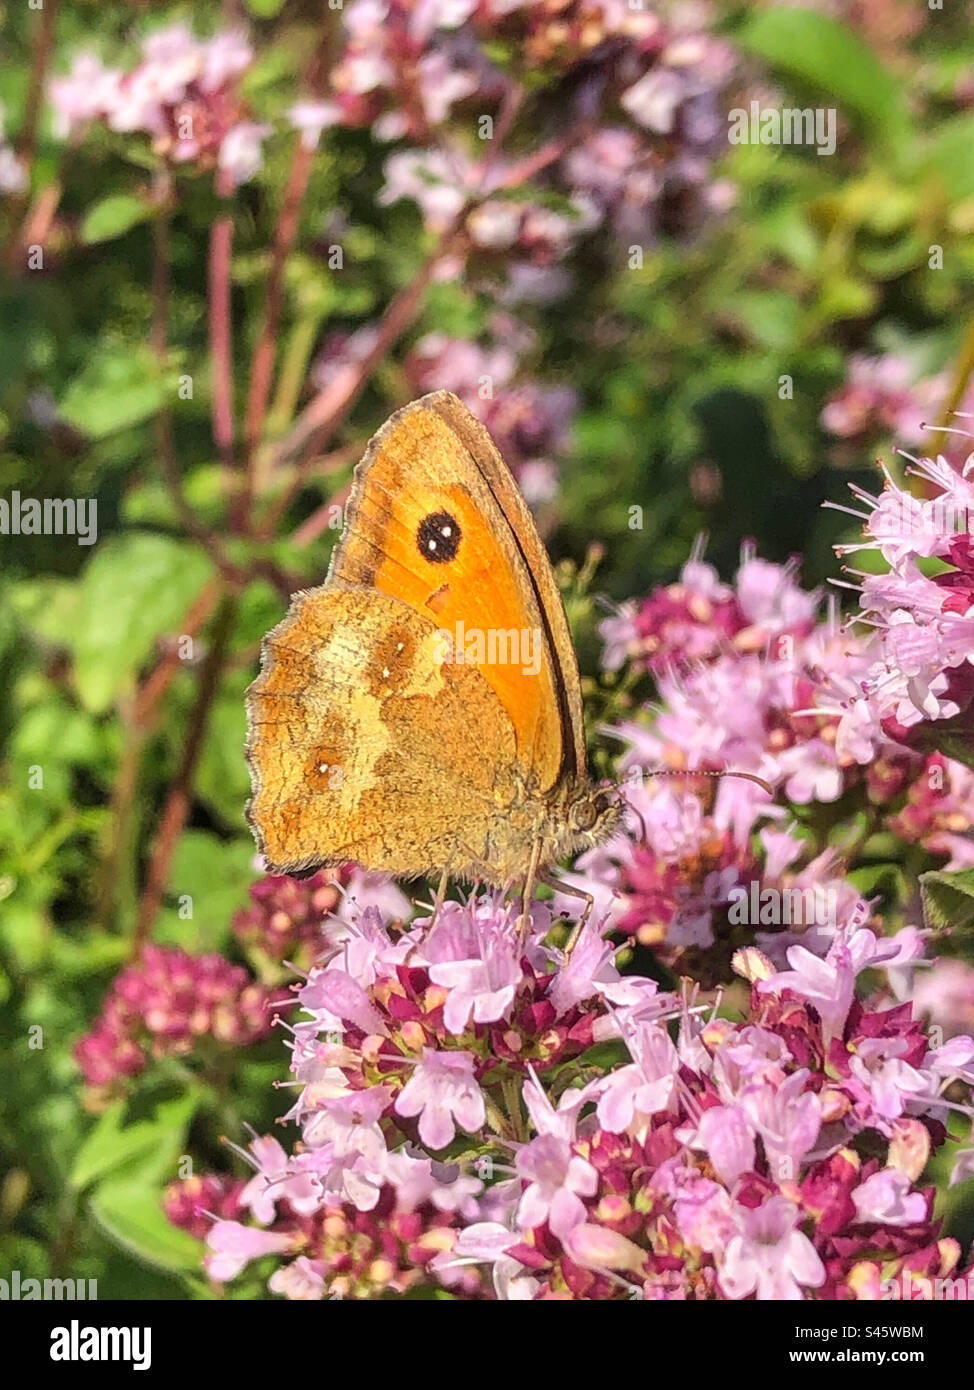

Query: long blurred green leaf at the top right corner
[738,7,910,145]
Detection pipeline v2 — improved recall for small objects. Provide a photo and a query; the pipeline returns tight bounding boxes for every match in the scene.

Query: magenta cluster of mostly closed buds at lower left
[74,945,272,1091]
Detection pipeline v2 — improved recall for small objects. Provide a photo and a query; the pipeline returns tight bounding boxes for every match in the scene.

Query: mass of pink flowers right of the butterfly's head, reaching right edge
[580,522,974,984]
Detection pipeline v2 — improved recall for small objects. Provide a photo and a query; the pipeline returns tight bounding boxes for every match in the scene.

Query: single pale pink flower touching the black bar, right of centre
[718,1197,825,1301]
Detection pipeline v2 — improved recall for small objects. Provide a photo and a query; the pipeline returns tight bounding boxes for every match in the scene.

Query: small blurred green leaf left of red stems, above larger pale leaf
[58,346,171,439]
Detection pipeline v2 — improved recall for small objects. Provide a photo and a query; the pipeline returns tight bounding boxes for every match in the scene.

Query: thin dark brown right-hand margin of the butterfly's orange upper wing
[419,391,585,778]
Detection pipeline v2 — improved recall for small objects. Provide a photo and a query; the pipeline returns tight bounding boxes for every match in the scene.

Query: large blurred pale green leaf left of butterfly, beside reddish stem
[74,531,211,714]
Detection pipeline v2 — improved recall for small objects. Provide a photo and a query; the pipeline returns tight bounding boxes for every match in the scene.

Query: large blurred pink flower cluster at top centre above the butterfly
[304,0,735,259]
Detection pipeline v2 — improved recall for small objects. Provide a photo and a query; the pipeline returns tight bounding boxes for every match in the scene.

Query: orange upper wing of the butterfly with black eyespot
[328,392,585,792]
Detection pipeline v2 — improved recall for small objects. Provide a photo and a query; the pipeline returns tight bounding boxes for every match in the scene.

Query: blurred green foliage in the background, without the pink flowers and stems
[0,0,974,1298]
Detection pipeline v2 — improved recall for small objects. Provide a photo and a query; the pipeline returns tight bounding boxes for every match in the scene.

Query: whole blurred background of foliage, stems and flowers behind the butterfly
[0,0,974,1297]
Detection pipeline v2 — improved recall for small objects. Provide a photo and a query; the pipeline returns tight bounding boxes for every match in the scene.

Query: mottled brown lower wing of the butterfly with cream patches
[247,582,515,877]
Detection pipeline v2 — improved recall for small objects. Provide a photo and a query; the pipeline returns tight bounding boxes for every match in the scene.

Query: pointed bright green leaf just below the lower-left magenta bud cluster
[71,1087,200,1188]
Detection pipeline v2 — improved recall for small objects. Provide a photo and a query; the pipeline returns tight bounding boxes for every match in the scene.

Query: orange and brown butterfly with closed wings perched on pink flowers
[247,391,766,939]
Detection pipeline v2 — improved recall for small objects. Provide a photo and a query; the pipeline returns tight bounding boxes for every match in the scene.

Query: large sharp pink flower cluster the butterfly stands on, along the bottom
[200,898,974,1300]
